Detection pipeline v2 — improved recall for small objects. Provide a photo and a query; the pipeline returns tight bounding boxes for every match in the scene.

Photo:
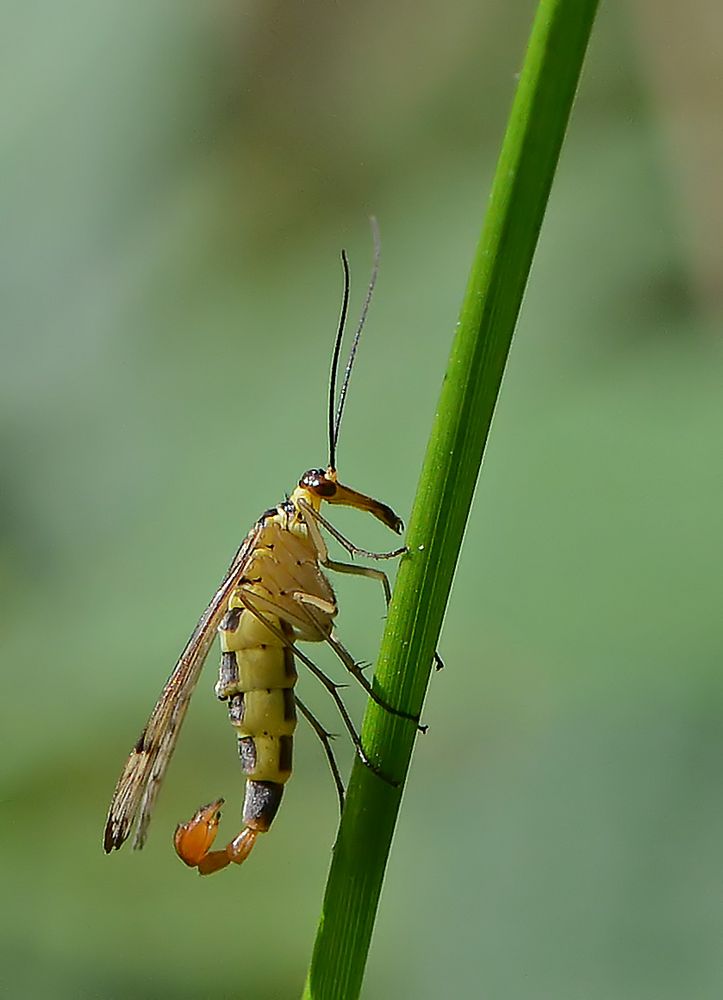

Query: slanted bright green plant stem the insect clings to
[304,0,597,1000]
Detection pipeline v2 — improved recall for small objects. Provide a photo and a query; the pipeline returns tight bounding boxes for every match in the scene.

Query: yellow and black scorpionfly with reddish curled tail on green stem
[103,226,418,875]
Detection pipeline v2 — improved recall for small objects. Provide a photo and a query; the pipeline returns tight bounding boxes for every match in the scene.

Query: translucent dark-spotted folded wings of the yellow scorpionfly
[103,522,261,853]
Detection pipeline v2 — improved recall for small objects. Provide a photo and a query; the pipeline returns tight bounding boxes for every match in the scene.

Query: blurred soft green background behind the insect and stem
[0,0,723,1000]
